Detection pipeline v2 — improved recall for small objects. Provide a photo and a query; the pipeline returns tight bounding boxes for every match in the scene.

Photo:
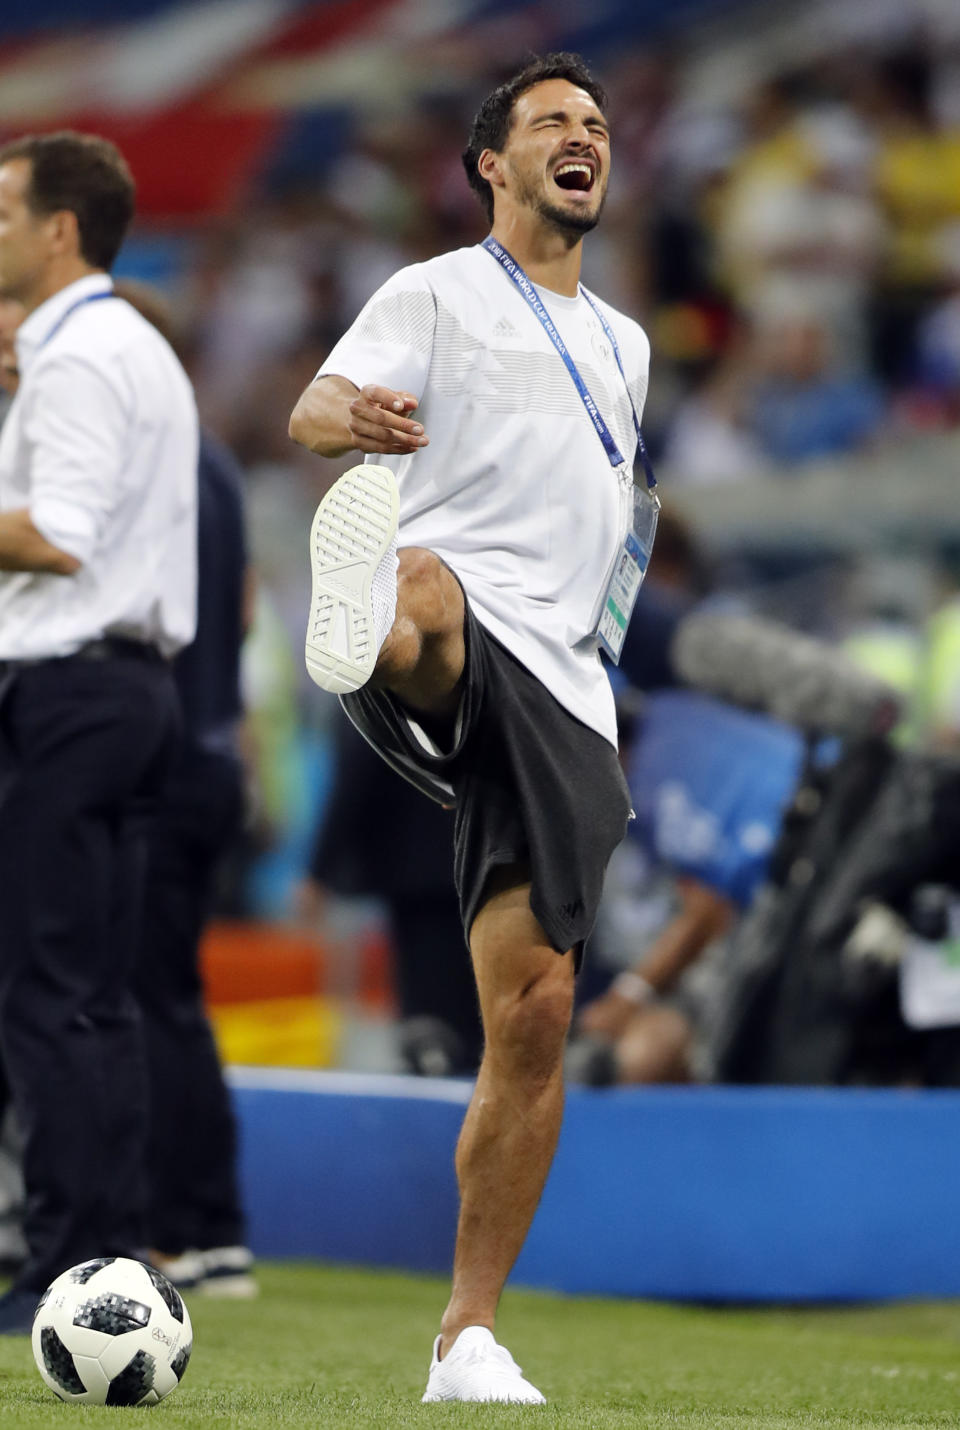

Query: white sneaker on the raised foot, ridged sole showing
[305,463,399,695]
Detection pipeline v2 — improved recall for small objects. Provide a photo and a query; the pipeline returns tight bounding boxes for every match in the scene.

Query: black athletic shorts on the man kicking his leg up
[341,599,630,964]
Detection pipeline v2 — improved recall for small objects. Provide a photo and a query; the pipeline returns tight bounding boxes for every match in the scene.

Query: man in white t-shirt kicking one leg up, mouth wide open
[290,54,650,1403]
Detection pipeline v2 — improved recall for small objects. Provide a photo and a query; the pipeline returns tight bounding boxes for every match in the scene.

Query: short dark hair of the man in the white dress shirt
[0,129,134,270]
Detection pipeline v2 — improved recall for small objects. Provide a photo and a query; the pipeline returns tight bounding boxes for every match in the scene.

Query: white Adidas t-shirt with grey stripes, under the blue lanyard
[318,246,650,744]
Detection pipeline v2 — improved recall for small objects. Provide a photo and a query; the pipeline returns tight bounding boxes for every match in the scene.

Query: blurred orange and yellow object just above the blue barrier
[200,921,393,1067]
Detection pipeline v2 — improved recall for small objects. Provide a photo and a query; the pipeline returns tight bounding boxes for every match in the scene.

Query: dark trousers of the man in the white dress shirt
[0,656,176,1291]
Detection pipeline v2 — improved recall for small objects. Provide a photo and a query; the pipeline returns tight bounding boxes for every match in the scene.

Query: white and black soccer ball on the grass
[33,1257,193,1406]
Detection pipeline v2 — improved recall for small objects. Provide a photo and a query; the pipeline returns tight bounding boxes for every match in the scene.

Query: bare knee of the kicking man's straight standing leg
[484,955,574,1081]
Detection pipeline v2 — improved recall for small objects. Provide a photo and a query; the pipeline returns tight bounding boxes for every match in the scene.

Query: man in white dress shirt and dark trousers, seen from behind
[0,133,197,1334]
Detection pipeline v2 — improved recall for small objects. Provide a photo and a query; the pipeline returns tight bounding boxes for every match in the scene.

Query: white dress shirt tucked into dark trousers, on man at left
[0,273,199,659]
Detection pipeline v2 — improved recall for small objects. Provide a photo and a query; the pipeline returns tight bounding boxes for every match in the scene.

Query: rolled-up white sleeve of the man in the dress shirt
[23,353,129,562]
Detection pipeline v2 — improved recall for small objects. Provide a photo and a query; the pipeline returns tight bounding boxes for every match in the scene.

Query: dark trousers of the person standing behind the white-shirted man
[136,744,243,1254]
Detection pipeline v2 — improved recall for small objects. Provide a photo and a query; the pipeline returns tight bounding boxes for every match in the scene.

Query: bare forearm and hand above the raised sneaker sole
[290,375,429,456]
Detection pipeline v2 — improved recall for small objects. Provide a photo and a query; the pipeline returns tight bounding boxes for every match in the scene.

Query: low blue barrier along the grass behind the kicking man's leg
[230,1068,960,1301]
